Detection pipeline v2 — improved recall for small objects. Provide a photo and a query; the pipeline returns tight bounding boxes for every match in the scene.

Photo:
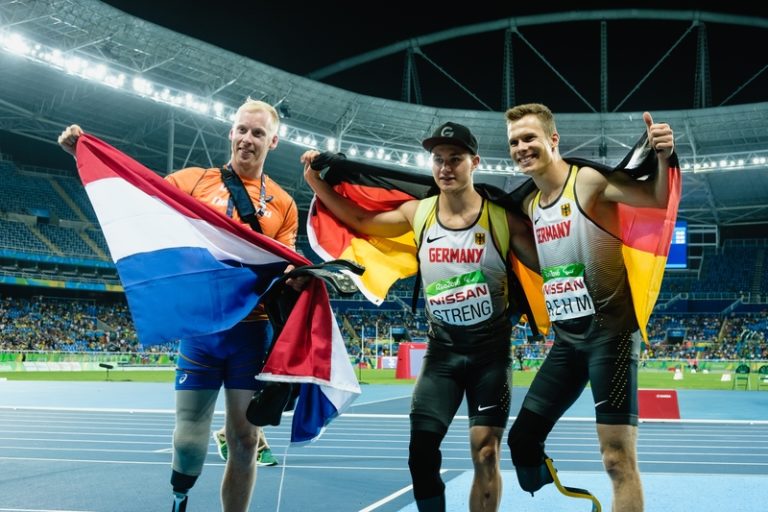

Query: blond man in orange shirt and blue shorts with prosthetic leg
[58,99,305,512]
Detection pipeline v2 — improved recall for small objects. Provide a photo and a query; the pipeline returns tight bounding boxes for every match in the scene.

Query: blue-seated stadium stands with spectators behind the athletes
[0,154,768,369]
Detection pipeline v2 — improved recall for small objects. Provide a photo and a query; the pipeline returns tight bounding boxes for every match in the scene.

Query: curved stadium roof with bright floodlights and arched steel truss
[0,0,768,226]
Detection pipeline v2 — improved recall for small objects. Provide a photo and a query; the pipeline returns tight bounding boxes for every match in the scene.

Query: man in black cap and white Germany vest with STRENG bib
[301,122,538,512]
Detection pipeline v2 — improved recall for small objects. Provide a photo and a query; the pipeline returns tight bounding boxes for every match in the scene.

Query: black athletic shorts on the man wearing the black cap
[411,342,512,435]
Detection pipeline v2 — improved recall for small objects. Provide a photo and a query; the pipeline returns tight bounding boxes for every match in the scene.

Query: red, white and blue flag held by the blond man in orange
[77,135,360,444]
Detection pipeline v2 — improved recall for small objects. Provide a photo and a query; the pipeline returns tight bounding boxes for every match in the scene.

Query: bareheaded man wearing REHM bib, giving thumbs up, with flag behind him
[506,104,680,512]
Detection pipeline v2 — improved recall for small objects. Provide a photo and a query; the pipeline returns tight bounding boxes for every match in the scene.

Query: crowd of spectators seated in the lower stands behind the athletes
[0,296,768,360]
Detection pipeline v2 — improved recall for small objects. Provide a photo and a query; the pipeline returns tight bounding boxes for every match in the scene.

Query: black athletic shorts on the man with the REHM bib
[523,331,642,425]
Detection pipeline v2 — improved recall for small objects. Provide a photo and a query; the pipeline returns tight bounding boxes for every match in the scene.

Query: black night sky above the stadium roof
[106,0,768,112]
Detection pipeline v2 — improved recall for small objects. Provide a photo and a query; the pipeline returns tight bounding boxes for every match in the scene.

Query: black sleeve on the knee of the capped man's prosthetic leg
[408,430,445,500]
